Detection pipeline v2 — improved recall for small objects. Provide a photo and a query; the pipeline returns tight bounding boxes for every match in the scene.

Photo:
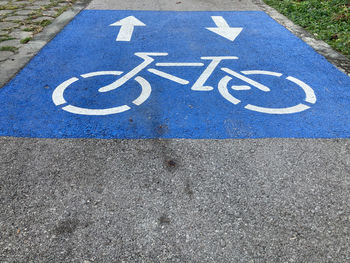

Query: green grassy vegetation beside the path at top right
[264,0,350,58]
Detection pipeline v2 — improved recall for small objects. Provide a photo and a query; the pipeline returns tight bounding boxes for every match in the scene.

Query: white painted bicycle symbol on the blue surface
[52,52,316,115]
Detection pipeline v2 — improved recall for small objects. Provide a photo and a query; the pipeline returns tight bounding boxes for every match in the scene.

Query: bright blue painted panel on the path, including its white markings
[0,10,350,138]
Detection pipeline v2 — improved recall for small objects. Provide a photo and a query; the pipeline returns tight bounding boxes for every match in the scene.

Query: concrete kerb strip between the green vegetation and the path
[252,0,350,76]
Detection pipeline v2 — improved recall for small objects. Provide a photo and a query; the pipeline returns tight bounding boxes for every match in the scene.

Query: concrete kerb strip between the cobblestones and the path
[0,0,91,88]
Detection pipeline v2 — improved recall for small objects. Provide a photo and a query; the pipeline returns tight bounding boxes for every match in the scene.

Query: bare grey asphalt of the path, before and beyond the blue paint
[0,0,350,263]
